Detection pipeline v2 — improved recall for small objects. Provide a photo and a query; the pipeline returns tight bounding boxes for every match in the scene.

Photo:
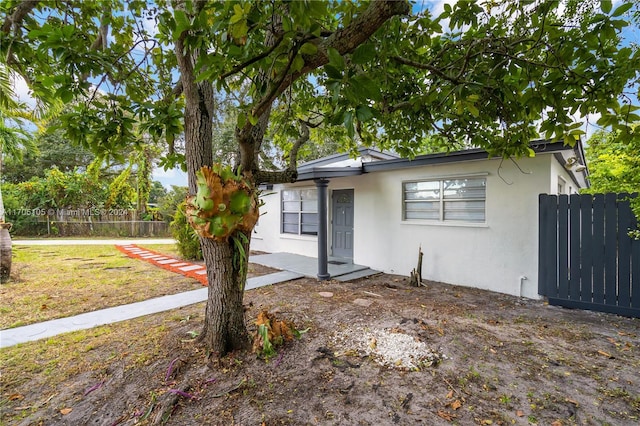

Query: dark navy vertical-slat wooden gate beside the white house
[538,194,640,318]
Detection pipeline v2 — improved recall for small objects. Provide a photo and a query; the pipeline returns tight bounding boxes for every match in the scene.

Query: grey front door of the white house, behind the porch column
[331,189,353,259]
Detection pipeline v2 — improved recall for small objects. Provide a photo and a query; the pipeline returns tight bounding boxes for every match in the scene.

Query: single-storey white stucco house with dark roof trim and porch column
[251,141,588,298]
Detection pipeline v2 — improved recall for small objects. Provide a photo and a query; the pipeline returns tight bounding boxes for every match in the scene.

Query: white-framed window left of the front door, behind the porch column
[282,189,318,235]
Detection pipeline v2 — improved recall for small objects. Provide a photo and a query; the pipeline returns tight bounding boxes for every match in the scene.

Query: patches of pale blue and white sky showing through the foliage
[8,0,640,189]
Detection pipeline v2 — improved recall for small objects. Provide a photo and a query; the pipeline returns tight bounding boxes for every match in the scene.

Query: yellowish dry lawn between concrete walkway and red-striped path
[0,245,201,329]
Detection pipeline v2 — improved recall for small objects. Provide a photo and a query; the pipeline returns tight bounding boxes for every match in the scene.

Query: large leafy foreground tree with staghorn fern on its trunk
[0,0,640,354]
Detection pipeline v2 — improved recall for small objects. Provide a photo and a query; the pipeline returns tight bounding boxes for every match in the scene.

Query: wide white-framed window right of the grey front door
[402,178,487,222]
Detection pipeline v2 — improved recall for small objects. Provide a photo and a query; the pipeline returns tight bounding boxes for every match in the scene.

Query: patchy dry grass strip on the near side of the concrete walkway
[0,303,204,424]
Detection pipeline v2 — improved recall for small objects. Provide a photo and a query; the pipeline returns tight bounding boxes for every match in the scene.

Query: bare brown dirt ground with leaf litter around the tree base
[0,275,640,426]
